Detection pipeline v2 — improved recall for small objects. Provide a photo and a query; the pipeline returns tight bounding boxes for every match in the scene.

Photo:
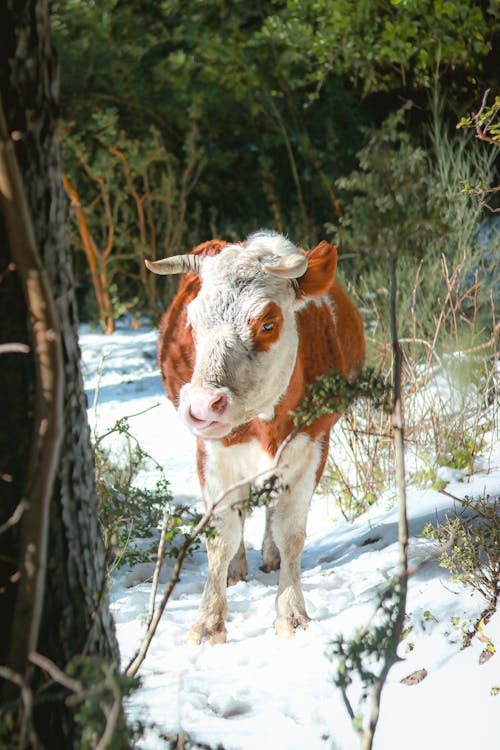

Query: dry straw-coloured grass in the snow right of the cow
[321,256,500,519]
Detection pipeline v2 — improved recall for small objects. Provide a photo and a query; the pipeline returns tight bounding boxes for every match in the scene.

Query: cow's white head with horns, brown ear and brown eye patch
[146,232,337,439]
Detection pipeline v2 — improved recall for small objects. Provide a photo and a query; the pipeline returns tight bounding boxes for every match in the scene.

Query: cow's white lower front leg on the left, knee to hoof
[188,509,241,645]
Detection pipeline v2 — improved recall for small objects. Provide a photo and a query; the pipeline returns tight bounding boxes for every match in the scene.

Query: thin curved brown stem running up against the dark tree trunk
[0,92,63,700]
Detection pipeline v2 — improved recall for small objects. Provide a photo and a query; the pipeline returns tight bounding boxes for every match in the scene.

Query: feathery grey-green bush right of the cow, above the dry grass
[326,94,500,349]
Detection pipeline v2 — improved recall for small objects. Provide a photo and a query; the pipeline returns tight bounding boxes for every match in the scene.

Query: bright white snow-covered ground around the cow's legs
[81,326,500,750]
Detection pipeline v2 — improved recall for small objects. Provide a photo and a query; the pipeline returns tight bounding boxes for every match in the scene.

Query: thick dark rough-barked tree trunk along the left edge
[0,0,118,748]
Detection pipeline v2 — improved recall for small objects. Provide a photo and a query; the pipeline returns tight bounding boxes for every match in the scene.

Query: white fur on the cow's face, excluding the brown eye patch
[179,234,304,438]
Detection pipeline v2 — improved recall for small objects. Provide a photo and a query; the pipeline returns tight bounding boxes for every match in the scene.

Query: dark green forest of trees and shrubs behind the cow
[50,0,500,335]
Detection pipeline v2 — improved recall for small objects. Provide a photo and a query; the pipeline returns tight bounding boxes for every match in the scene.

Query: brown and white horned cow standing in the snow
[146,231,365,644]
